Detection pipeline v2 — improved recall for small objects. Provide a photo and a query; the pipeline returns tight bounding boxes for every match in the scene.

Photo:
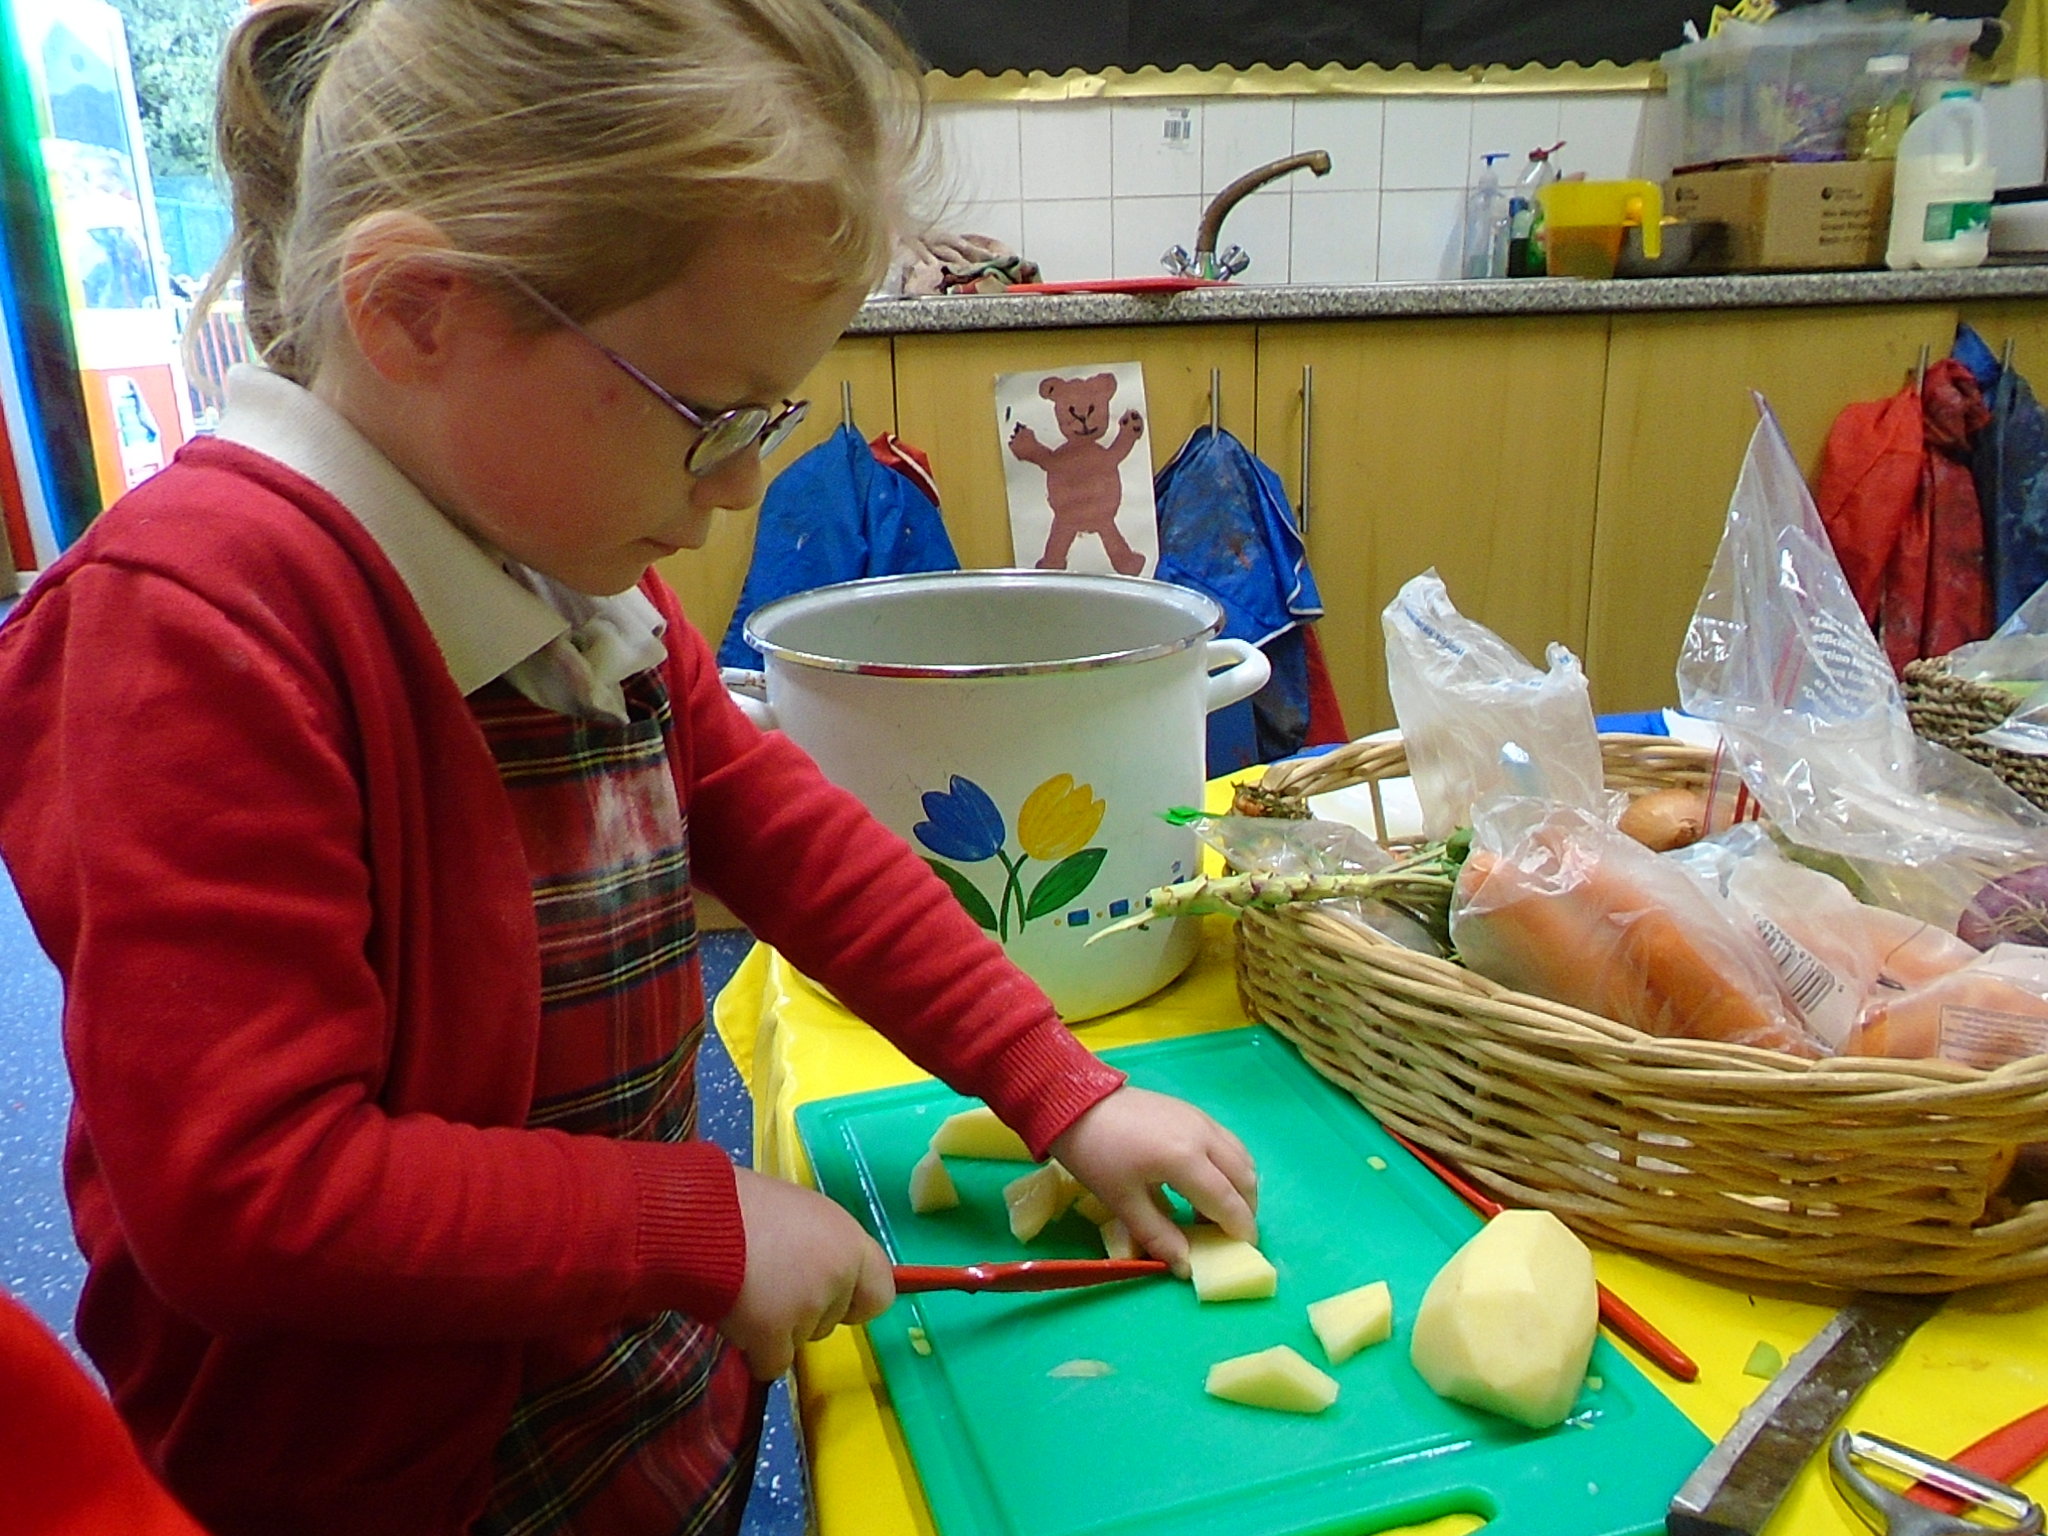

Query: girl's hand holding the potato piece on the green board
[1053,1087,1260,1278]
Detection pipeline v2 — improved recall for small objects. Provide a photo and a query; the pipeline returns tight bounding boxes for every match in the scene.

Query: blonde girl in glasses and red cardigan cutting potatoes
[0,0,1255,1536]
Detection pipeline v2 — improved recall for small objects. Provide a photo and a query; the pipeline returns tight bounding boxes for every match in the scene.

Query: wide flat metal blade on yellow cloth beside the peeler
[1665,1296,1946,1536]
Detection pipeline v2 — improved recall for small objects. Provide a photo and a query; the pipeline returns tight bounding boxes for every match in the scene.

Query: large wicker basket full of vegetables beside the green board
[1237,735,2048,1292]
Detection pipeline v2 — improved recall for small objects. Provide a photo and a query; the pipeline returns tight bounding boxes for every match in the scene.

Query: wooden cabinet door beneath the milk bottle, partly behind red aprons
[1583,305,1956,711]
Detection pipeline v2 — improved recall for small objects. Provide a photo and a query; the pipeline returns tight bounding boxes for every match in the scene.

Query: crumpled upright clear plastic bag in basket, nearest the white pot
[1380,567,1608,838]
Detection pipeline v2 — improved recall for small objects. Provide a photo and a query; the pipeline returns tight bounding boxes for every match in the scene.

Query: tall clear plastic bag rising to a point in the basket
[1677,397,2048,932]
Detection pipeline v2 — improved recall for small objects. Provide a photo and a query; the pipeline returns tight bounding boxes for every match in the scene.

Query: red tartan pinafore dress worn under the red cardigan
[469,670,764,1536]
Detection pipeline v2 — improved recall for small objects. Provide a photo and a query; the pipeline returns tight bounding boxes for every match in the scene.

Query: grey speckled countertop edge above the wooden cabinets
[848,262,2048,336]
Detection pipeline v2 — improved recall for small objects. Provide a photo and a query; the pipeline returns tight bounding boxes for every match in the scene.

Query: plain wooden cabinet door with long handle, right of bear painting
[1255,315,1608,733]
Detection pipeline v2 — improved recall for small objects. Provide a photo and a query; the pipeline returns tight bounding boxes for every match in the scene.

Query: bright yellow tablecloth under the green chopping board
[717,786,2048,1536]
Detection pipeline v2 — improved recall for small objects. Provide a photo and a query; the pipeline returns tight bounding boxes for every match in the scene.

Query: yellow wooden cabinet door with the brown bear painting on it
[895,326,1255,567]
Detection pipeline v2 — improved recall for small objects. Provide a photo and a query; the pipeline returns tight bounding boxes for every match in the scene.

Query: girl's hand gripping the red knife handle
[719,1167,895,1380]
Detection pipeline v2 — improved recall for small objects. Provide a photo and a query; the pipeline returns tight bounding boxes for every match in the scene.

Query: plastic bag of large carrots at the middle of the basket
[1450,801,1821,1057]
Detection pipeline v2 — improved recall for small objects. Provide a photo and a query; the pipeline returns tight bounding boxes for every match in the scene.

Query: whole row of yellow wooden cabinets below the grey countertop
[664,301,2048,733]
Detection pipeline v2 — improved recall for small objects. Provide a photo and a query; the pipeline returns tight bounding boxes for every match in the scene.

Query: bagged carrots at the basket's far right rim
[1843,944,2048,1067]
